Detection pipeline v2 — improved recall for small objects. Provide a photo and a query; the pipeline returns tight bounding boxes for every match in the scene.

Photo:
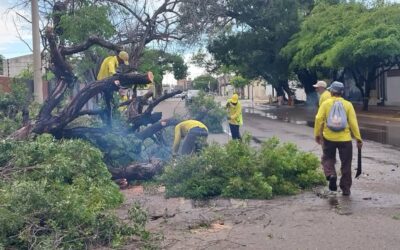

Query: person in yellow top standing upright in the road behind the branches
[226,94,243,140]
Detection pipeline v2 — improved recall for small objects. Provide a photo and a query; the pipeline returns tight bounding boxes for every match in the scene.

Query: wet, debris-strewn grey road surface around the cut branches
[118,100,400,249]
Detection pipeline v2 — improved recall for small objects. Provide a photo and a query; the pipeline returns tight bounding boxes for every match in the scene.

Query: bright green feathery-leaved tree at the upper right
[282,3,400,110]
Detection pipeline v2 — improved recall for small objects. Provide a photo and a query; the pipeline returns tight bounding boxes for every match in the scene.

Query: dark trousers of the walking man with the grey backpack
[322,138,353,191]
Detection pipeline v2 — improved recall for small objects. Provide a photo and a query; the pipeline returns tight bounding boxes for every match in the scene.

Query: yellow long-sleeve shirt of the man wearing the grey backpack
[314,96,361,141]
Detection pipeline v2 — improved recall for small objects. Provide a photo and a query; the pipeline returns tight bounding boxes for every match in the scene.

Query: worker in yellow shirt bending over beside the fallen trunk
[172,120,208,155]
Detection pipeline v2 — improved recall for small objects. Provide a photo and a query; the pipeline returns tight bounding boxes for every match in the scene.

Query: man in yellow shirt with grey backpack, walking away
[314,81,363,196]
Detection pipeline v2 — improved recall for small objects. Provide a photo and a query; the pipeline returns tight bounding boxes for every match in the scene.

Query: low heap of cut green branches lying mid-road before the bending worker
[160,137,325,199]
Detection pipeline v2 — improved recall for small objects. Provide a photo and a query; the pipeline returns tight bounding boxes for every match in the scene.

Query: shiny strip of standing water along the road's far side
[244,105,400,147]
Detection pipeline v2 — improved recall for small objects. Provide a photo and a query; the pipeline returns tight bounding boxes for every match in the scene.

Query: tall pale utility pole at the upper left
[31,0,43,103]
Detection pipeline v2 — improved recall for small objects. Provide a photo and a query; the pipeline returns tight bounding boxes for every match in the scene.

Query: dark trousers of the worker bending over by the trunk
[181,127,208,155]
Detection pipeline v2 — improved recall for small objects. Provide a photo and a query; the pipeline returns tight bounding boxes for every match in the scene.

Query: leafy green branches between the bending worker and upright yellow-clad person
[187,92,226,133]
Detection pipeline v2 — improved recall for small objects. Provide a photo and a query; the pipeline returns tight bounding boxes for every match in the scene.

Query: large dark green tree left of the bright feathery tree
[208,0,312,95]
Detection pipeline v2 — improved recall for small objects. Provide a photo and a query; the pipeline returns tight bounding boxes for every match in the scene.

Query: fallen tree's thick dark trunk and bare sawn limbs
[9,10,181,180]
